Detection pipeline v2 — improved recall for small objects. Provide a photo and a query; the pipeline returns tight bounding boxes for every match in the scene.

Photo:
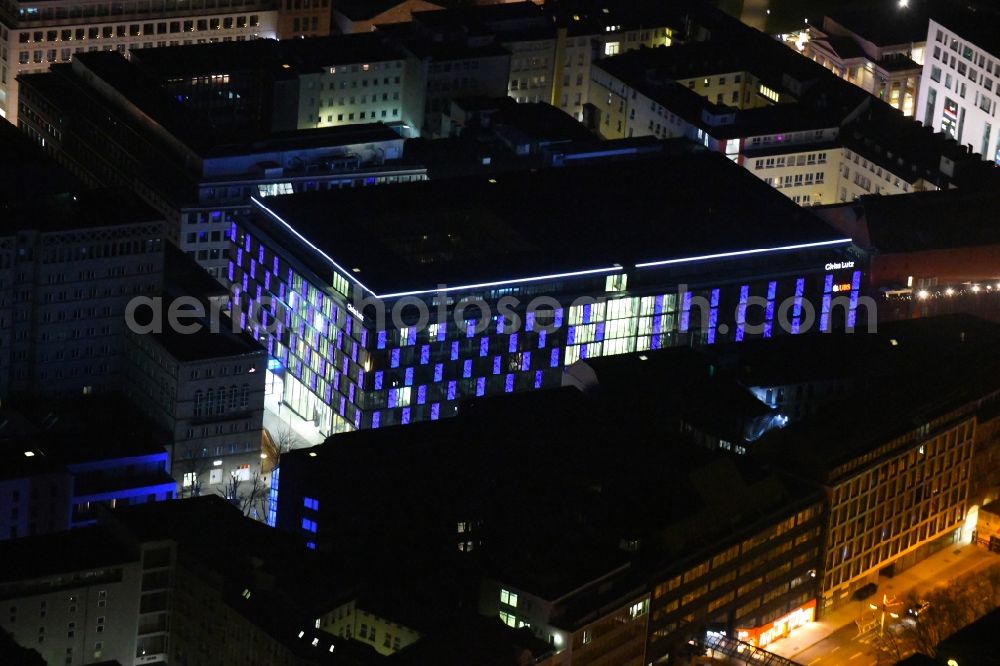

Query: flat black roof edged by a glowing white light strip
[254,153,843,295]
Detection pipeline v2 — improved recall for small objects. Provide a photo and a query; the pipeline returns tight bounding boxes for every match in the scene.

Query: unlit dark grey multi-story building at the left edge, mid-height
[0,191,165,394]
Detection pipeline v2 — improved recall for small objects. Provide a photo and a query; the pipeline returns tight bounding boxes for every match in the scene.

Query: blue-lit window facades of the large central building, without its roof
[230,220,861,433]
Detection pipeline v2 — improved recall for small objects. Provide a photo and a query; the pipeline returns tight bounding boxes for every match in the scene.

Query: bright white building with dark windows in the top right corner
[915,13,1000,162]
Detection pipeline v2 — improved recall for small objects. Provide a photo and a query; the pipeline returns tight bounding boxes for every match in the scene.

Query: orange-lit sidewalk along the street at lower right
[767,544,1000,659]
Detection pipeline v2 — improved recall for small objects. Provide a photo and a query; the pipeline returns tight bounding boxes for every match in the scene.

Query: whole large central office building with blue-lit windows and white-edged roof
[228,152,864,434]
